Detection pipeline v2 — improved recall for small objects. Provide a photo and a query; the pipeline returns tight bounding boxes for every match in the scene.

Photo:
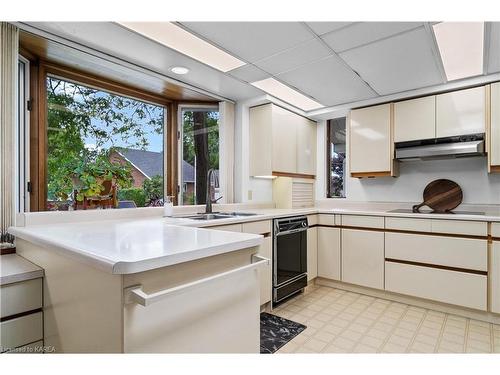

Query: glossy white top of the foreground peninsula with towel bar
[9,218,262,274]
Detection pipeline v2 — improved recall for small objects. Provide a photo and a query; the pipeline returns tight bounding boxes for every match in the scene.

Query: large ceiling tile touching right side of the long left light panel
[182,22,314,63]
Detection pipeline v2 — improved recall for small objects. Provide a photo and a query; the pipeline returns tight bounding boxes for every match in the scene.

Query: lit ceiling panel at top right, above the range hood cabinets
[432,22,484,81]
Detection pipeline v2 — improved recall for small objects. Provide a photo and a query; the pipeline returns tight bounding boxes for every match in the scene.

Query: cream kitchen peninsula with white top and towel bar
[10,218,267,353]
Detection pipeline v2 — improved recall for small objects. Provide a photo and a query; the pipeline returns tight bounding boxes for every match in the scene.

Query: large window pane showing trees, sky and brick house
[46,77,165,210]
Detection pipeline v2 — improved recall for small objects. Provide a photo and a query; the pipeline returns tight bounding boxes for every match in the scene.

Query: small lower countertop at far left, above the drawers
[0,254,43,285]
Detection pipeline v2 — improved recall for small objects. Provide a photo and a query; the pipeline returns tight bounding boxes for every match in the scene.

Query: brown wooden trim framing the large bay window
[26,59,218,212]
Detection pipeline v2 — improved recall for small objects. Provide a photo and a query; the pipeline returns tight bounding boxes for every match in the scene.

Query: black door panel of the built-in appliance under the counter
[273,228,307,287]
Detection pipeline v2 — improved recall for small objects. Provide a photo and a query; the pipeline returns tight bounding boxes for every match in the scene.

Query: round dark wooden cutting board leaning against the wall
[413,179,463,212]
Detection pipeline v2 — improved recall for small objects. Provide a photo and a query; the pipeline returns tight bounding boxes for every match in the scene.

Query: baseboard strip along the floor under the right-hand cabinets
[312,277,500,324]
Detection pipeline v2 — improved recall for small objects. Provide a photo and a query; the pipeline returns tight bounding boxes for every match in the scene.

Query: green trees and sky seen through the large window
[47,77,164,204]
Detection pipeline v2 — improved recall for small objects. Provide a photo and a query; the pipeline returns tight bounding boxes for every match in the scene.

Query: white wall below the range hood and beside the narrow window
[316,124,500,204]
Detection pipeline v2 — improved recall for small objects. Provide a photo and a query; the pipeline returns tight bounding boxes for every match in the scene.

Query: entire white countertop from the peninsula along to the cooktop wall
[9,202,500,274]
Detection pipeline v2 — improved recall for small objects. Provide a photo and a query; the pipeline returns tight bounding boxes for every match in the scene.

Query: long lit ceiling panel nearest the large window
[115,22,245,72]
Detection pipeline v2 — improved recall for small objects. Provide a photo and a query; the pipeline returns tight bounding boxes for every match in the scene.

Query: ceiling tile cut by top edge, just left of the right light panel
[321,22,423,52]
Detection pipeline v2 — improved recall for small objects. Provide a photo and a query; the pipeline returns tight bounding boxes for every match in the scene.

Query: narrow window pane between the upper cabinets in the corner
[327,117,347,198]
